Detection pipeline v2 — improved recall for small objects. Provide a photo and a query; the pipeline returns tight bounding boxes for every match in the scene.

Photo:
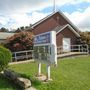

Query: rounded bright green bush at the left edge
[0,46,12,72]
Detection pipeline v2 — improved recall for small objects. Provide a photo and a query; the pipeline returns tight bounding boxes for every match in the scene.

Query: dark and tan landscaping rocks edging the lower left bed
[3,70,31,89]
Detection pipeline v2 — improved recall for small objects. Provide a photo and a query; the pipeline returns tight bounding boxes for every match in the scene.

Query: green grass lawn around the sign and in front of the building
[0,56,90,90]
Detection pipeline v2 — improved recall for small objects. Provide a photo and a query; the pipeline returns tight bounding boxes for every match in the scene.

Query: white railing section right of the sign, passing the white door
[57,44,89,54]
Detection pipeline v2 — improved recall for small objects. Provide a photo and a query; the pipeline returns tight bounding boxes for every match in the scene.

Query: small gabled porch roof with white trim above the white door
[52,24,80,37]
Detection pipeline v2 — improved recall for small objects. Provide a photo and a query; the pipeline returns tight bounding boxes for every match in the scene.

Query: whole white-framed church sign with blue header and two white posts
[34,31,57,80]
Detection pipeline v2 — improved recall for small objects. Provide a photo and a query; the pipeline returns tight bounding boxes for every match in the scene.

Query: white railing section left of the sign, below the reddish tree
[12,50,33,61]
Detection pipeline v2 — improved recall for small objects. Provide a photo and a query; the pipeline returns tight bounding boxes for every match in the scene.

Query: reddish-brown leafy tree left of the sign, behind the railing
[5,31,34,52]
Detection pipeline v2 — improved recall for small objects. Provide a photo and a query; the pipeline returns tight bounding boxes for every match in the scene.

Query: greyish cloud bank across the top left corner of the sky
[0,0,50,14]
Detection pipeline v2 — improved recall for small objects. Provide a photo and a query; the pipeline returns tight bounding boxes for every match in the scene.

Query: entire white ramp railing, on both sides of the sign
[12,45,89,61]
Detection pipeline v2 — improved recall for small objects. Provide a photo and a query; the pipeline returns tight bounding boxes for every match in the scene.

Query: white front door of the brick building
[63,38,71,52]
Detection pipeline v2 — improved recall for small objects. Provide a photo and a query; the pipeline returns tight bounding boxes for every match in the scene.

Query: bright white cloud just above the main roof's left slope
[11,12,47,28]
